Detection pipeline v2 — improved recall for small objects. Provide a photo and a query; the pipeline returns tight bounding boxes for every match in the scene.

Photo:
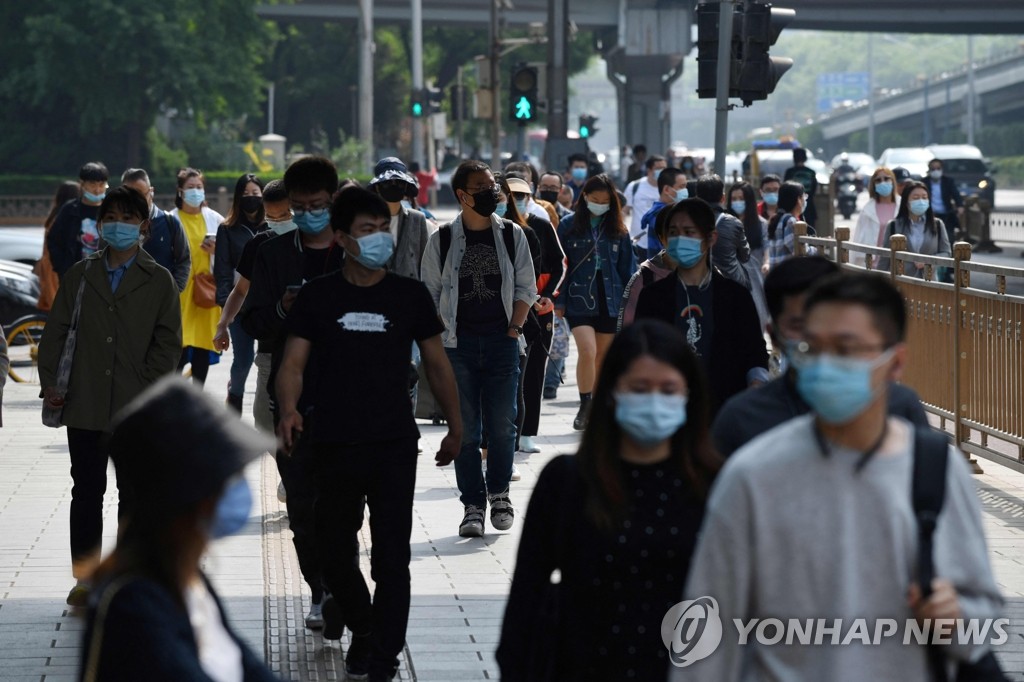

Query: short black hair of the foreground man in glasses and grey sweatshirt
[804,272,906,347]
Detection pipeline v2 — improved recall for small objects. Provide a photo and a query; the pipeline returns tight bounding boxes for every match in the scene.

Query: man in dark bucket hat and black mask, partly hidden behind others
[370,157,430,280]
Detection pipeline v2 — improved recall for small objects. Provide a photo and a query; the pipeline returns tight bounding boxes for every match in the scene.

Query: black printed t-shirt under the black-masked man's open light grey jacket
[456,228,509,336]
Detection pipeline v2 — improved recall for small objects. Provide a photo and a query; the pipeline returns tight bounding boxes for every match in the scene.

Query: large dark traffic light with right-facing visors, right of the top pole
[735,2,797,105]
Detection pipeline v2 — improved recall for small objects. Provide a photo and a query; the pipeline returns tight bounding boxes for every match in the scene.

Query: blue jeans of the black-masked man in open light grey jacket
[445,334,519,507]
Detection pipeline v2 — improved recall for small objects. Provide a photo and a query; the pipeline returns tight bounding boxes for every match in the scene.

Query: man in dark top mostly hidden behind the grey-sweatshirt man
[712,256,929,457]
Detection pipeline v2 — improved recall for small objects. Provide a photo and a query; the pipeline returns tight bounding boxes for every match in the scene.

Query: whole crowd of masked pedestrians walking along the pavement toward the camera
[28,150,1000,680]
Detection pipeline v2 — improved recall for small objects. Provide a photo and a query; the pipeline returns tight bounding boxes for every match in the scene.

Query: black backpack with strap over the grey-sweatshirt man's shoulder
[912,429,1008,682]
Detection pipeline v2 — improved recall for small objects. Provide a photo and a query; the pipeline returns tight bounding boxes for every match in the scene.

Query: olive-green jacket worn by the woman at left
[39,249,181,431]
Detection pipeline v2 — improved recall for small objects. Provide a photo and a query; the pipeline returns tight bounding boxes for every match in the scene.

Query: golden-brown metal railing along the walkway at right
[797,223,1024,472]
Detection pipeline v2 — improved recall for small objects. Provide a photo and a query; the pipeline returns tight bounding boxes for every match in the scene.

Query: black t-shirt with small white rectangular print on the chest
[286,271,444,443]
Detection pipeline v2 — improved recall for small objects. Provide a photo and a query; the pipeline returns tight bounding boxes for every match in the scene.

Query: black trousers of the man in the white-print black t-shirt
[313,438,417,676]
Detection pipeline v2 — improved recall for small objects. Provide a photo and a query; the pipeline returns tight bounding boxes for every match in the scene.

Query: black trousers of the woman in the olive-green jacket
[68,426,133,580]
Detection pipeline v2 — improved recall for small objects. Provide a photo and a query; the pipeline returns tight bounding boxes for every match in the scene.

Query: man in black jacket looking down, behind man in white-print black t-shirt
[240,157,342,628]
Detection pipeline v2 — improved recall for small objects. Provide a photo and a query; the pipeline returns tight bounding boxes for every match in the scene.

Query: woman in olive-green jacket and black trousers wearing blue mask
[39,186,181,606]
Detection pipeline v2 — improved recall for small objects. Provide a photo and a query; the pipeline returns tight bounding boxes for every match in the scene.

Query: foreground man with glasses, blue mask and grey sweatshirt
[670,273,1002,682]
